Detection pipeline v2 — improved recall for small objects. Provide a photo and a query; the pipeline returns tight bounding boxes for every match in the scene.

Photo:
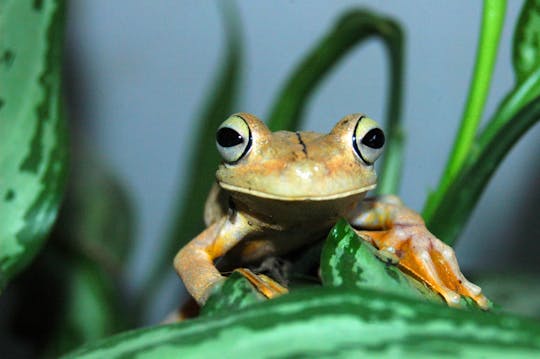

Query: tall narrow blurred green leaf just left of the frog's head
[142,2,242,302]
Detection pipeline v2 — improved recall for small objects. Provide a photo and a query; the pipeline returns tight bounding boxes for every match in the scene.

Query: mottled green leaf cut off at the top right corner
[512,0,540,83]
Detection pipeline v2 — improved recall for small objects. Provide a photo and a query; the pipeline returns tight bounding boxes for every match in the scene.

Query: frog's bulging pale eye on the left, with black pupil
[216,116,251,163]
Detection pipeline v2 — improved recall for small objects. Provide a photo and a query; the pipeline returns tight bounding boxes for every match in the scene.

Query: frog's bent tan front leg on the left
[174,213,252,304]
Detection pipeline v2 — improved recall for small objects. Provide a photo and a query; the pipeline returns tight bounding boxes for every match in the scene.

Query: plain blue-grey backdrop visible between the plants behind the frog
[67,0,540,318]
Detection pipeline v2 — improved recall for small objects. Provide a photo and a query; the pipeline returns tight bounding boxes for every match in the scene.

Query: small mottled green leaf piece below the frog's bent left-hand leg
[200,272,266,316]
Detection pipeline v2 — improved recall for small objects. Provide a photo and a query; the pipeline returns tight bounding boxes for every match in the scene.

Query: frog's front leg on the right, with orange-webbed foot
[349,196,488,308]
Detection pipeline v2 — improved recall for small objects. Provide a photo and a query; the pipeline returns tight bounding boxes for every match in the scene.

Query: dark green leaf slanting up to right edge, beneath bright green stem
[427,97,540,244]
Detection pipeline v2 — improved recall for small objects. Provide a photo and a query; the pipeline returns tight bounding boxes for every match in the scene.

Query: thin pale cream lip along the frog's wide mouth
[218,182,377,201]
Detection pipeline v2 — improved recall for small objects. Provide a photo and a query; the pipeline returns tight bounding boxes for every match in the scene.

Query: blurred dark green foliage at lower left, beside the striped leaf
[45,148,136,356]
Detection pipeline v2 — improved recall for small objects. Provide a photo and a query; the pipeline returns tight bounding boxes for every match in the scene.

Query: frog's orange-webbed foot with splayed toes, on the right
[356,228,488,309]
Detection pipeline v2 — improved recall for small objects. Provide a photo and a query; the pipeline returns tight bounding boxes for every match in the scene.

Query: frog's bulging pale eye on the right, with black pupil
[353,116,384,165]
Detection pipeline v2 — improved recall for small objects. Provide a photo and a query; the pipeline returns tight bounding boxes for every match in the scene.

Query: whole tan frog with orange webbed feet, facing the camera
[174,113,489,309]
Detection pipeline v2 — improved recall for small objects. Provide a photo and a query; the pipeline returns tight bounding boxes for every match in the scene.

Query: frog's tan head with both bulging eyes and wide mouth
[216,113,384,201]
